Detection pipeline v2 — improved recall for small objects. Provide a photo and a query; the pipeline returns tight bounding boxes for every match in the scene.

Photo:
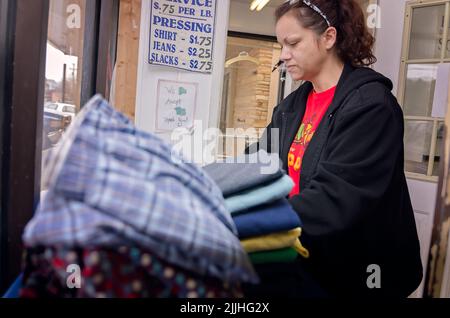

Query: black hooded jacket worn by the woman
[250,65,422,297]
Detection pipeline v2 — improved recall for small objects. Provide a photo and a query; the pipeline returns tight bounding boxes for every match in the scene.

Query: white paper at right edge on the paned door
[431,63,450,117]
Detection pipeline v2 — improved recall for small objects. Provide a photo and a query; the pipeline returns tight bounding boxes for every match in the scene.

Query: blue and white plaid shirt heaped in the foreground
[23,96,257,282]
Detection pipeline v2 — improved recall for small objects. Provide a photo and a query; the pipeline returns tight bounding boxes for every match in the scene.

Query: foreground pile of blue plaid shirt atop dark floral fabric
[21,96,258,298]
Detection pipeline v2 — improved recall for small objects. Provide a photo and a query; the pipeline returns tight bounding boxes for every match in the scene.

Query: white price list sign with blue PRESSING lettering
[148,0,216,73]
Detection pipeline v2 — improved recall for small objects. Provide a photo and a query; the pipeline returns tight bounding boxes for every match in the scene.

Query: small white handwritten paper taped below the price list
[156,80,198,131]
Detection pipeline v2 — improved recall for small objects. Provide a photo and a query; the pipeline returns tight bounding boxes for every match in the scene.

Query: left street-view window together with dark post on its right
[41,0,119,185]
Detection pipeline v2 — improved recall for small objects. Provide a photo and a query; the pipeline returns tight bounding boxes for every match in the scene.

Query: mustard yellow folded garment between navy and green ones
[241,228,301,253]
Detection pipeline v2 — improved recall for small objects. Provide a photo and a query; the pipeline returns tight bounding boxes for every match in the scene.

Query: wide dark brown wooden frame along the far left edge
[0,0,49,289]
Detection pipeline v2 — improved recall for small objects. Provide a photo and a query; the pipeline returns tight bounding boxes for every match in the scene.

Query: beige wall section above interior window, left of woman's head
[230,0,276,36]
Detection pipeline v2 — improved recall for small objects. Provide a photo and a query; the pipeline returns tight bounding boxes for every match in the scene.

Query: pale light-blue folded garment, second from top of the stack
[225,175,294,213]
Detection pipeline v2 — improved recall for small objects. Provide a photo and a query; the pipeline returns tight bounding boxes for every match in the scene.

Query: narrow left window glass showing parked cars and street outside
[42,0,86,154]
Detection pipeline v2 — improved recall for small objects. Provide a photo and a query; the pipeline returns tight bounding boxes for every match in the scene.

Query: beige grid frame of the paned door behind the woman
[397,0,450,182]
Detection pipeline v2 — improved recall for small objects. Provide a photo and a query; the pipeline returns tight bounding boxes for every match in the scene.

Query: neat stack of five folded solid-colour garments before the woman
[204,150,309,264]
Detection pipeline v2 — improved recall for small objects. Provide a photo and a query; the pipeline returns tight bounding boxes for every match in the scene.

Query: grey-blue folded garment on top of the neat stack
[203,150,284,198]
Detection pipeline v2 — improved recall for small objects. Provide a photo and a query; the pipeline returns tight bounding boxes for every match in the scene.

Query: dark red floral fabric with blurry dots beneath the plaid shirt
[20,247,242,298]
